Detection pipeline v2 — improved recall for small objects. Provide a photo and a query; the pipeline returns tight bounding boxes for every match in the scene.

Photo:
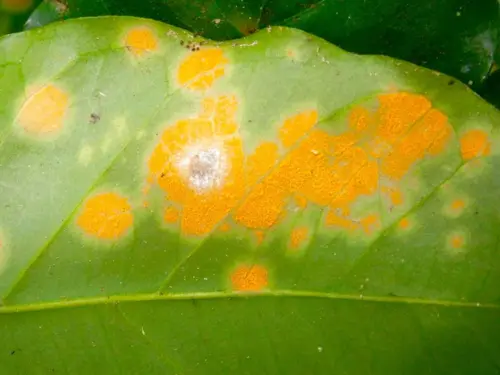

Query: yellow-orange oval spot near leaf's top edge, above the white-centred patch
[177,48,229,90]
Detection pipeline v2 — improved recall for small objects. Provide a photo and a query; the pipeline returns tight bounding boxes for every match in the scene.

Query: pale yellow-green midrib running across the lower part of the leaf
[0,289,500,314]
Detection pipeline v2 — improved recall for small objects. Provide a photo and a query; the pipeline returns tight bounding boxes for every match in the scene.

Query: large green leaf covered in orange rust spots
[0,17,500,375]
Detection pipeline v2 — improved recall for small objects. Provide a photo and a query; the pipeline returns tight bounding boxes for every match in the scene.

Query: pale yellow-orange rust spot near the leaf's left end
[17,84,69,135]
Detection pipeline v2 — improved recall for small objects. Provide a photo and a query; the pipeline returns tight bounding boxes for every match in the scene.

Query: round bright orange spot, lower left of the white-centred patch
[77,192,134,240]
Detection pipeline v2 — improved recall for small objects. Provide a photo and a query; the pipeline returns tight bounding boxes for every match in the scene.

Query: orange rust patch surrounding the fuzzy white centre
[148,96,246,235]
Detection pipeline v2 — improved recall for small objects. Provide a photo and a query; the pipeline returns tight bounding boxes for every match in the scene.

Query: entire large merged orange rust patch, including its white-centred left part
[149,93,452,235]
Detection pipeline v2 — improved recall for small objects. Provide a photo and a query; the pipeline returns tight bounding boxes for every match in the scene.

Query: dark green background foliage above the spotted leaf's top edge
[0,0,500,106]
